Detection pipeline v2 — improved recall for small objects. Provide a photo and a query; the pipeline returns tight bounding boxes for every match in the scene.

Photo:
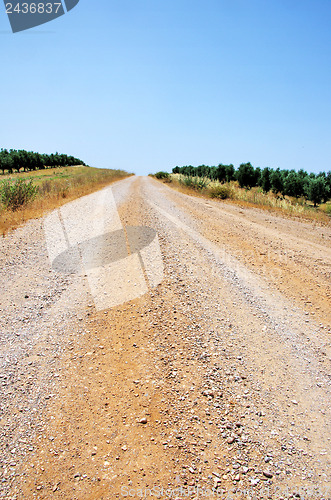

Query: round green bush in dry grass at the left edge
[0,179,38,212]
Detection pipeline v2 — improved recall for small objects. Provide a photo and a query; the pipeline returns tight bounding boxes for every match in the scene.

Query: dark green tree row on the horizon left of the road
[0,149,85,174]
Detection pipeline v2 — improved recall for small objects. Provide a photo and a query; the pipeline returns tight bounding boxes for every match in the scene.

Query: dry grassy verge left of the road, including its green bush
[0,166,132,235]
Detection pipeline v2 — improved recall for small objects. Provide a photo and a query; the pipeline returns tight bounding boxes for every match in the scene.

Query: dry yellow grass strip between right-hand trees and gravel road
[163,174,331,224]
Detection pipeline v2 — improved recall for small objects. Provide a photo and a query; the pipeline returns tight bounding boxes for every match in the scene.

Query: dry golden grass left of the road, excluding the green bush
[0,166,132,235]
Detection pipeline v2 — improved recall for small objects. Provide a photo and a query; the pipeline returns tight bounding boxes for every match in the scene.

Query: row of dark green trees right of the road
[172,163,331,206]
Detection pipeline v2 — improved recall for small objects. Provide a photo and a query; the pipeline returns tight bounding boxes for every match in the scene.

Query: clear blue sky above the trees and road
[0,0,331,174]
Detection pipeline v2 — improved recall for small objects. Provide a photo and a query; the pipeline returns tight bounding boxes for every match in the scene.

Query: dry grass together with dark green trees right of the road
[155,163,331,222]
